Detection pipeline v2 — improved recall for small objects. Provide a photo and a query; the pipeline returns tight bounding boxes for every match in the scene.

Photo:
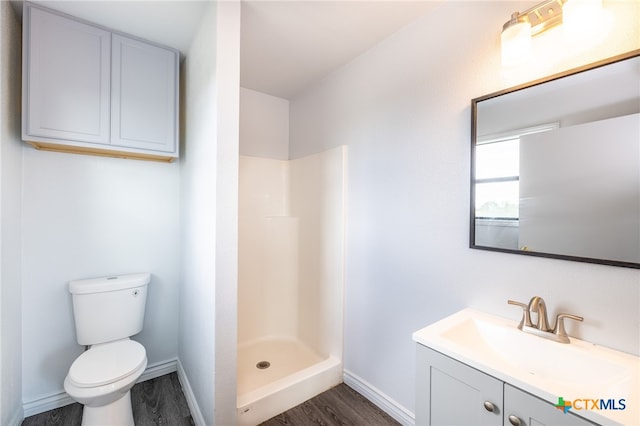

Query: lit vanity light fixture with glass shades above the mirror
[500,0,602,67]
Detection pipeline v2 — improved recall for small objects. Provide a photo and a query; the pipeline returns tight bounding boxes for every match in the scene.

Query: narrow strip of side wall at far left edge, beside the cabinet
[0,2,22,425]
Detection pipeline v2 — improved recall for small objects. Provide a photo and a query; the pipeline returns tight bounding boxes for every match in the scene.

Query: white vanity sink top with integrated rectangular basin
[413,309,640,425]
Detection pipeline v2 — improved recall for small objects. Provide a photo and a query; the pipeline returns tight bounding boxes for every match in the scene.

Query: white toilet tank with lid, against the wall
[69,273,151,345]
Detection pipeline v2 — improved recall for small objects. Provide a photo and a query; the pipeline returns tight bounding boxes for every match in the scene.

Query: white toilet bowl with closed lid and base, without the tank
[64,338,147,426]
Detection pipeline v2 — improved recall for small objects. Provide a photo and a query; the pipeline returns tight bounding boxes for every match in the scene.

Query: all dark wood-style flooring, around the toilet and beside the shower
[22,373,399,426]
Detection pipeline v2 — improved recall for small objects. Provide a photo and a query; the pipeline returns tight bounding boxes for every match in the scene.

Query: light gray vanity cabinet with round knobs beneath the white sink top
[416,344,594,426]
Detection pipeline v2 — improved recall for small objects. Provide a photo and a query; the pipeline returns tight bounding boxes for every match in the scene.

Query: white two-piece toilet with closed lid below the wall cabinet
[64,273,151,426]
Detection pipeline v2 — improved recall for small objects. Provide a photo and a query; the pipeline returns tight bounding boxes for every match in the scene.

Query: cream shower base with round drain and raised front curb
[237,337,342,426]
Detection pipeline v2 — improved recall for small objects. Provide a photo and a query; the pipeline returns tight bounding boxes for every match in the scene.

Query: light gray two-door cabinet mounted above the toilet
[22,3,179,161]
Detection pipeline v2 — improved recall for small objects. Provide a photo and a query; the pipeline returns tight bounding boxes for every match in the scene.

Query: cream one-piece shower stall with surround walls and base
[237,147,346,425]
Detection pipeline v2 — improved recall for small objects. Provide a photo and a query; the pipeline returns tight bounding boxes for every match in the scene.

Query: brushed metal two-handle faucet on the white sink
[507,296,584,343]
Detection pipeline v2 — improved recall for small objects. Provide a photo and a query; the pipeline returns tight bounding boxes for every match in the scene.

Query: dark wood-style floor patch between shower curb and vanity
[260,383,400,426]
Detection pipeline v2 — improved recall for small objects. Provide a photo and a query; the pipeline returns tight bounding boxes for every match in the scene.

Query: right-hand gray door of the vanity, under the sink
[504,384,594,426]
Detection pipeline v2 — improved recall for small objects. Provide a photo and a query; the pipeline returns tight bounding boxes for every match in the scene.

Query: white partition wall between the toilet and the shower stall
[178,2,240,425]
